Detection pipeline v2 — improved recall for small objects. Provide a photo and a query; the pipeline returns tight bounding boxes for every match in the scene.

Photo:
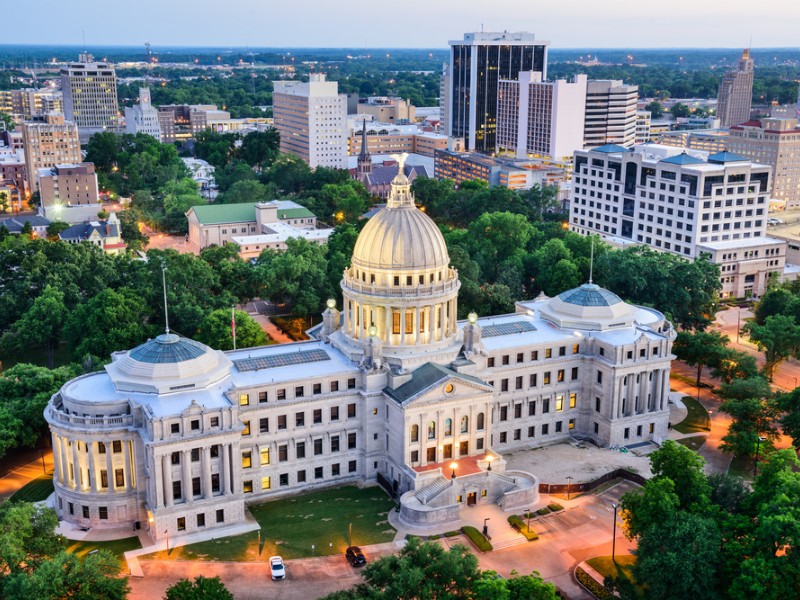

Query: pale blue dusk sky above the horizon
[14,0,800,48]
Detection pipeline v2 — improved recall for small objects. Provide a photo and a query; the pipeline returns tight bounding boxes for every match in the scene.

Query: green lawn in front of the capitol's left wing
[146,486,395,562]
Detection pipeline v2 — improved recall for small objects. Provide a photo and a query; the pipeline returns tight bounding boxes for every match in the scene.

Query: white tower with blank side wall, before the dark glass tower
[497,71,586,162]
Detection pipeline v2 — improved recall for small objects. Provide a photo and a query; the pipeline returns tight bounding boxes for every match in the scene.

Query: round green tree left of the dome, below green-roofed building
[256,238,330,315]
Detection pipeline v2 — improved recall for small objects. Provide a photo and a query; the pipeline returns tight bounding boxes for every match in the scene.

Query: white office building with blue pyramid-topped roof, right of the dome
[569,144,786,297]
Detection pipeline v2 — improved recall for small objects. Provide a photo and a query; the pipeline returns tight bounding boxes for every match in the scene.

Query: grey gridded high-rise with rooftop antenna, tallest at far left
[61,52,119,143]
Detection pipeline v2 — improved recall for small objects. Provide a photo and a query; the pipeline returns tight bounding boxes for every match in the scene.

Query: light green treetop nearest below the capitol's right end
[650,440,711,510]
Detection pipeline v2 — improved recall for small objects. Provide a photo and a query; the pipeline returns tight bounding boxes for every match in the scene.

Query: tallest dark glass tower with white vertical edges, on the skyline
[444,31,549,154]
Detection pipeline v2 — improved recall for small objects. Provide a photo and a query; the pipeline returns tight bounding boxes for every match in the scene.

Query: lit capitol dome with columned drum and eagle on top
[342,155,461,352]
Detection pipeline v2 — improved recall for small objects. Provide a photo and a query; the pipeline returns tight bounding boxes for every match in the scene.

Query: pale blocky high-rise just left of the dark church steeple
[272,73,347,169]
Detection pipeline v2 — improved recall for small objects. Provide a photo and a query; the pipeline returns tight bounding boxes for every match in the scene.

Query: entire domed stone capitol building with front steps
[45,165,675,540]
